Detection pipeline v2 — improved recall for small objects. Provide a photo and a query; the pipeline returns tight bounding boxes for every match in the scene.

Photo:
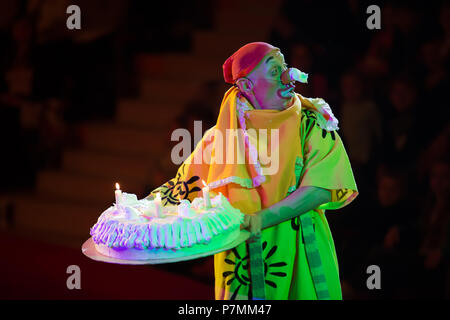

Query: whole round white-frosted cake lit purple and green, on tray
[90,193,244,260]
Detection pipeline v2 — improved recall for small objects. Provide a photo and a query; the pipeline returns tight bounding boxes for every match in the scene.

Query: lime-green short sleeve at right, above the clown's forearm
[300,110,358,210]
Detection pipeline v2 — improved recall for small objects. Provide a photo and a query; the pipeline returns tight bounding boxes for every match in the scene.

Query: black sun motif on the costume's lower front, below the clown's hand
[222,241,287,300]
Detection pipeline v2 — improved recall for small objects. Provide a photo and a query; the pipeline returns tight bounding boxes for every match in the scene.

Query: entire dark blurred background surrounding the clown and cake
[0,0,450,299]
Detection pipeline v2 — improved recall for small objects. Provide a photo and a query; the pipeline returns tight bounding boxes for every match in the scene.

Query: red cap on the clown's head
[222,42,279,83]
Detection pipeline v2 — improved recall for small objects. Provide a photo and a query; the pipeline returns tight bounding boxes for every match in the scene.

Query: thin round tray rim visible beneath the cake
[81,230,250,265]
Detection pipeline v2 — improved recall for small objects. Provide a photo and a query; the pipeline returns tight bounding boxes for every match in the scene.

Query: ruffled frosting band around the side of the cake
[90,196,244,250]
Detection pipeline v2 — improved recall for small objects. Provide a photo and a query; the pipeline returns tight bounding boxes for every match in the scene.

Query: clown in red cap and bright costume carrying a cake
[149,42,358,300]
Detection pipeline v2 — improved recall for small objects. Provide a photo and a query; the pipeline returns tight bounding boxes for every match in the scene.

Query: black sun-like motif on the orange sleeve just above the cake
[152,164,202,206]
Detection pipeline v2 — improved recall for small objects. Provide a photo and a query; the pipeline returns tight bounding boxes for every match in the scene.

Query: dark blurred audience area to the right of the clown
[270,0,450,299]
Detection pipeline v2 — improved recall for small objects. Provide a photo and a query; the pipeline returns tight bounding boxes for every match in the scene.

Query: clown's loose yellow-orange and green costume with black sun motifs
[150,87,358,299]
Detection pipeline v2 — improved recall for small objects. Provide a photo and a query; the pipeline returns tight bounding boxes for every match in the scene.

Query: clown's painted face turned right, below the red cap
[246,50,295,110]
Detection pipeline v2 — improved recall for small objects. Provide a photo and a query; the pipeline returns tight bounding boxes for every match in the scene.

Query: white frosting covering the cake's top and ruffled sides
[90,193,244,254]
